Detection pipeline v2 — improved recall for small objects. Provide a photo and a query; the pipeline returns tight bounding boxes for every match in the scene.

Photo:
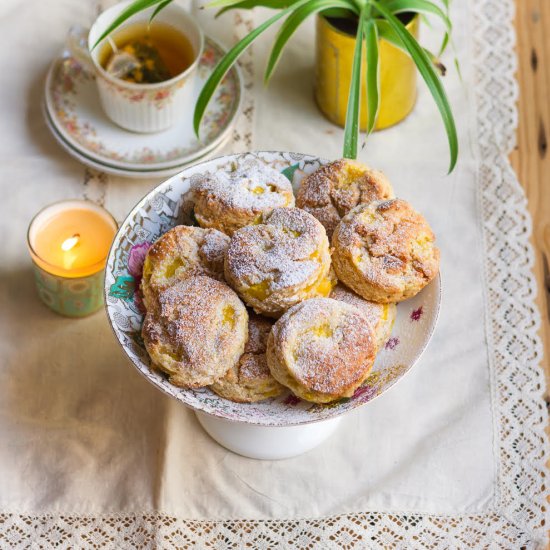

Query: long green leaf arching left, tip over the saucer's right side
[193,0,309,136]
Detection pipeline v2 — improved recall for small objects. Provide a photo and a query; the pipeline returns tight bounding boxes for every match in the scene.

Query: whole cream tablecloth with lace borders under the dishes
[0,0,548,549]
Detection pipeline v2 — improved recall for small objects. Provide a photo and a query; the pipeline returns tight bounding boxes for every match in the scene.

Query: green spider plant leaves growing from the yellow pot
[94,0,458,172]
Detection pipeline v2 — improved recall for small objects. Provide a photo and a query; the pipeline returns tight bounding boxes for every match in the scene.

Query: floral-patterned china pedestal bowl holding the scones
[105,152,441,459]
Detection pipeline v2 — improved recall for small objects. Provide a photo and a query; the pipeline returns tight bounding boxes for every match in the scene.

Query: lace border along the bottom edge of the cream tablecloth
[0,513,537,550]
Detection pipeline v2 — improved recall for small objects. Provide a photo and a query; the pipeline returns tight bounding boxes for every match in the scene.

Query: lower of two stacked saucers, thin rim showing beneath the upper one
[42,104,230,179]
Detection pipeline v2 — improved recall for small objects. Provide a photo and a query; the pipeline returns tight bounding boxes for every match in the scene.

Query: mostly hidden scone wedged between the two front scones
[210,313,284,403]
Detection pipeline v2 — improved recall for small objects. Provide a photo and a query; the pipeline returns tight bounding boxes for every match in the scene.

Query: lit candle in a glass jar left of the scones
[27,200,117,317]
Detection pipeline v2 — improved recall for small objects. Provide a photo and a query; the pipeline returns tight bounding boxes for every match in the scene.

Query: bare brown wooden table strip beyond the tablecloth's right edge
[510,0,550,404]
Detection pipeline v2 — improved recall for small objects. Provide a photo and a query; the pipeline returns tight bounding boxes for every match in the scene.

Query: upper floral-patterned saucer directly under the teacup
[45,37,242,172]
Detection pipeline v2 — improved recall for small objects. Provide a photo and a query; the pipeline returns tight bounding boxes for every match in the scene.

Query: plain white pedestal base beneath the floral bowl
[195,411,342,460]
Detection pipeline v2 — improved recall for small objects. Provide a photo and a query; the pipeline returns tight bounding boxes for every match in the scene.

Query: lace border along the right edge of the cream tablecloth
[472,0,548,547]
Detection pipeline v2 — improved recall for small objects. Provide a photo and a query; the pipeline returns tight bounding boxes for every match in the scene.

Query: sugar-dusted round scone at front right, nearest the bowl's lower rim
[267,298,376,403]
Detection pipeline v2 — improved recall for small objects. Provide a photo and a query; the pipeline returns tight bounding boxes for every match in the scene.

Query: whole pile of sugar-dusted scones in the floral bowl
[141,160,439,403]
